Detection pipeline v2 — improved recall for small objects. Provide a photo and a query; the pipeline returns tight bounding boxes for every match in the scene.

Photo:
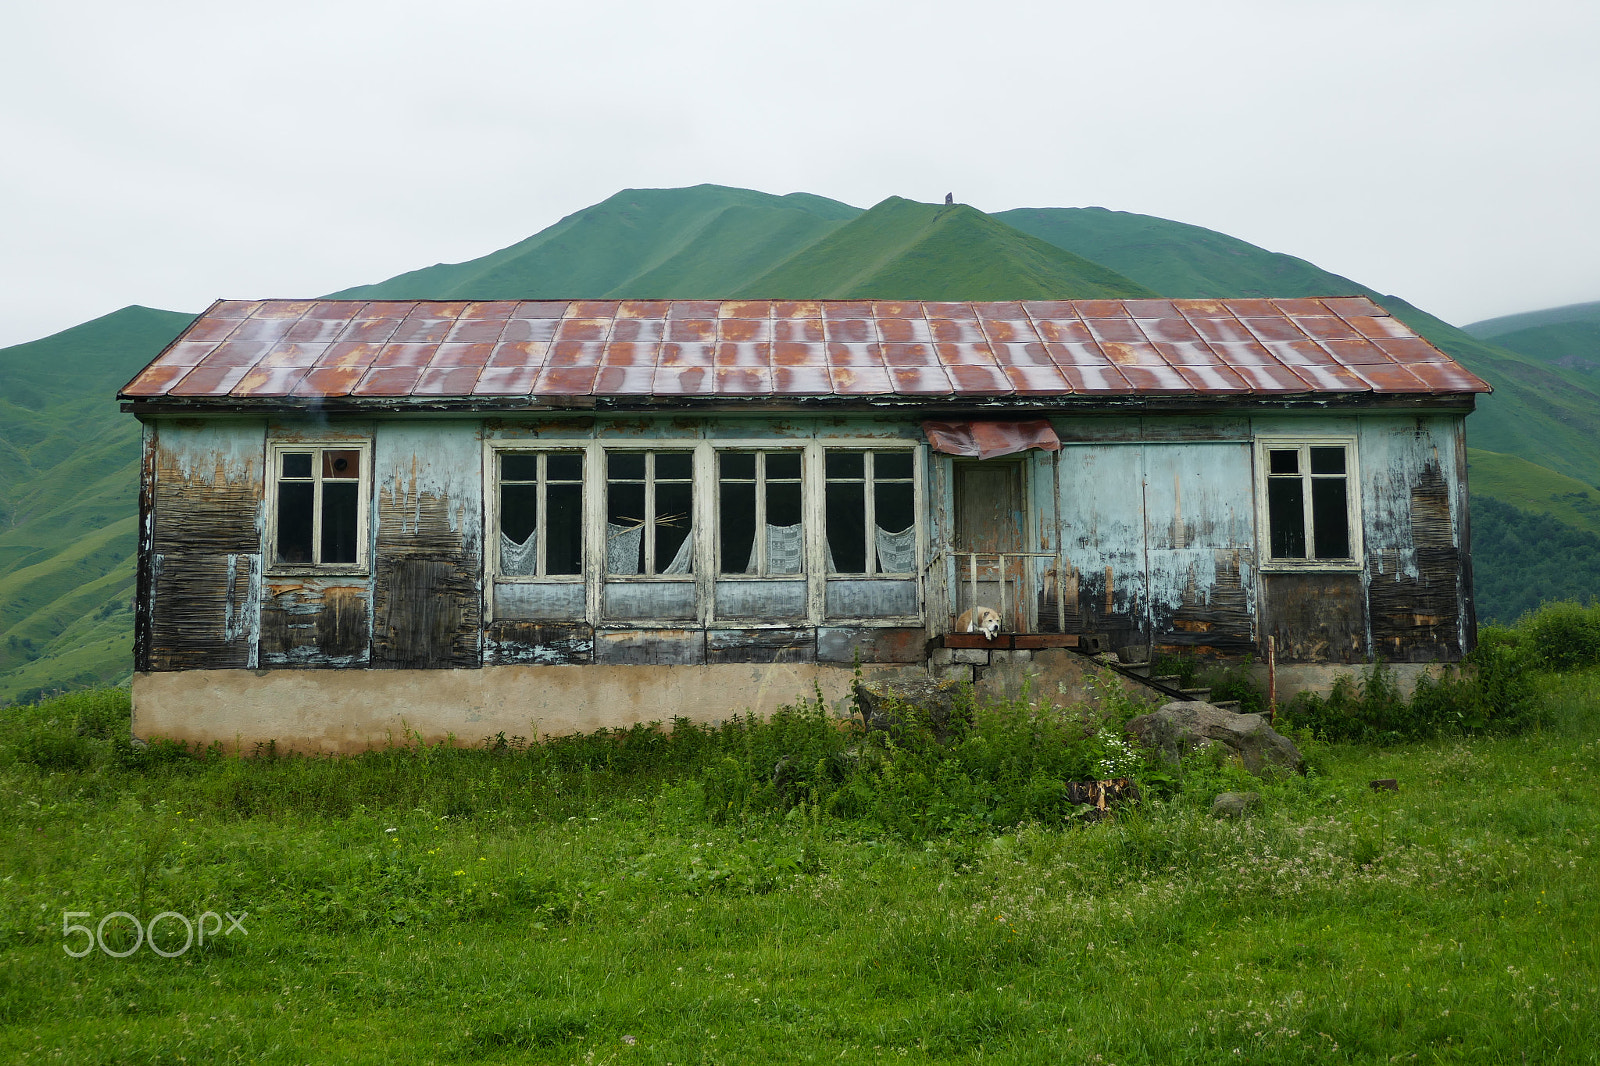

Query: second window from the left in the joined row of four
[605,448,696,579]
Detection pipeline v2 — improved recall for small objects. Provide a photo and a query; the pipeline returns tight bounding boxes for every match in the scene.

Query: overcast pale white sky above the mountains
[0,0,1600,344]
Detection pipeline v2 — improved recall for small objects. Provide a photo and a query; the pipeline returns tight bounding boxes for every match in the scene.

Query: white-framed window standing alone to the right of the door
[1256,437,1362,570]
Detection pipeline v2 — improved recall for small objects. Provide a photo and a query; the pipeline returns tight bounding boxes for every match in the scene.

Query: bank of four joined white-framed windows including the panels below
[485,435,926,627]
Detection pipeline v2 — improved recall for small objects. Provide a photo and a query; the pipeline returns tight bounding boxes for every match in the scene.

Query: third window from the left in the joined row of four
[717,448,806,578]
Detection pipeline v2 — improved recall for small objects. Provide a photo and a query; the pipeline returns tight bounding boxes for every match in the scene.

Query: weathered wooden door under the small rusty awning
[950,459,1030,632]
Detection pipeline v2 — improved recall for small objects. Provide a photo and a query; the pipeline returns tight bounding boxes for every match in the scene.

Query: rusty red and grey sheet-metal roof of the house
[120,296,1490,408]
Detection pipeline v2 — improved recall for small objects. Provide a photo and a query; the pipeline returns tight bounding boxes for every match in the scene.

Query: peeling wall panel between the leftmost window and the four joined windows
[371,421,483,669]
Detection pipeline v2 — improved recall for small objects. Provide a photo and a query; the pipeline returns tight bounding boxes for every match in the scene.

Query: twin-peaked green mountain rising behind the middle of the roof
[334,186,1154,299]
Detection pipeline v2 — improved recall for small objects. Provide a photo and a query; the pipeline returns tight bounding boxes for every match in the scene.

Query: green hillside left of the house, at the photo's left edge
[0,307,194,703]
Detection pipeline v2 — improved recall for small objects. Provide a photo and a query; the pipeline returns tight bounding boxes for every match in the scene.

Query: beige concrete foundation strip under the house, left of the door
[133,663,925,754]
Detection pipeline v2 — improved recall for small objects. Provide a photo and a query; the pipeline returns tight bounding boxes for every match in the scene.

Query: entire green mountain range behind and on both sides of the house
[0,186,1600,703]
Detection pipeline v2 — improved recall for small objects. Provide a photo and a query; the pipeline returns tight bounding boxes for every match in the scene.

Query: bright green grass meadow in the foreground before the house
[0,671,1600,1063]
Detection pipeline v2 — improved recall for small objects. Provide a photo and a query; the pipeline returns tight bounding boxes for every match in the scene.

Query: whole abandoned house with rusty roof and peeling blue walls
[120,298,1488,751]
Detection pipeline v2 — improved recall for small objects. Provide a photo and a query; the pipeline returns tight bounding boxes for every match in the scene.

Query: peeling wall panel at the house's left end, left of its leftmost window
[145,421,266,671]
